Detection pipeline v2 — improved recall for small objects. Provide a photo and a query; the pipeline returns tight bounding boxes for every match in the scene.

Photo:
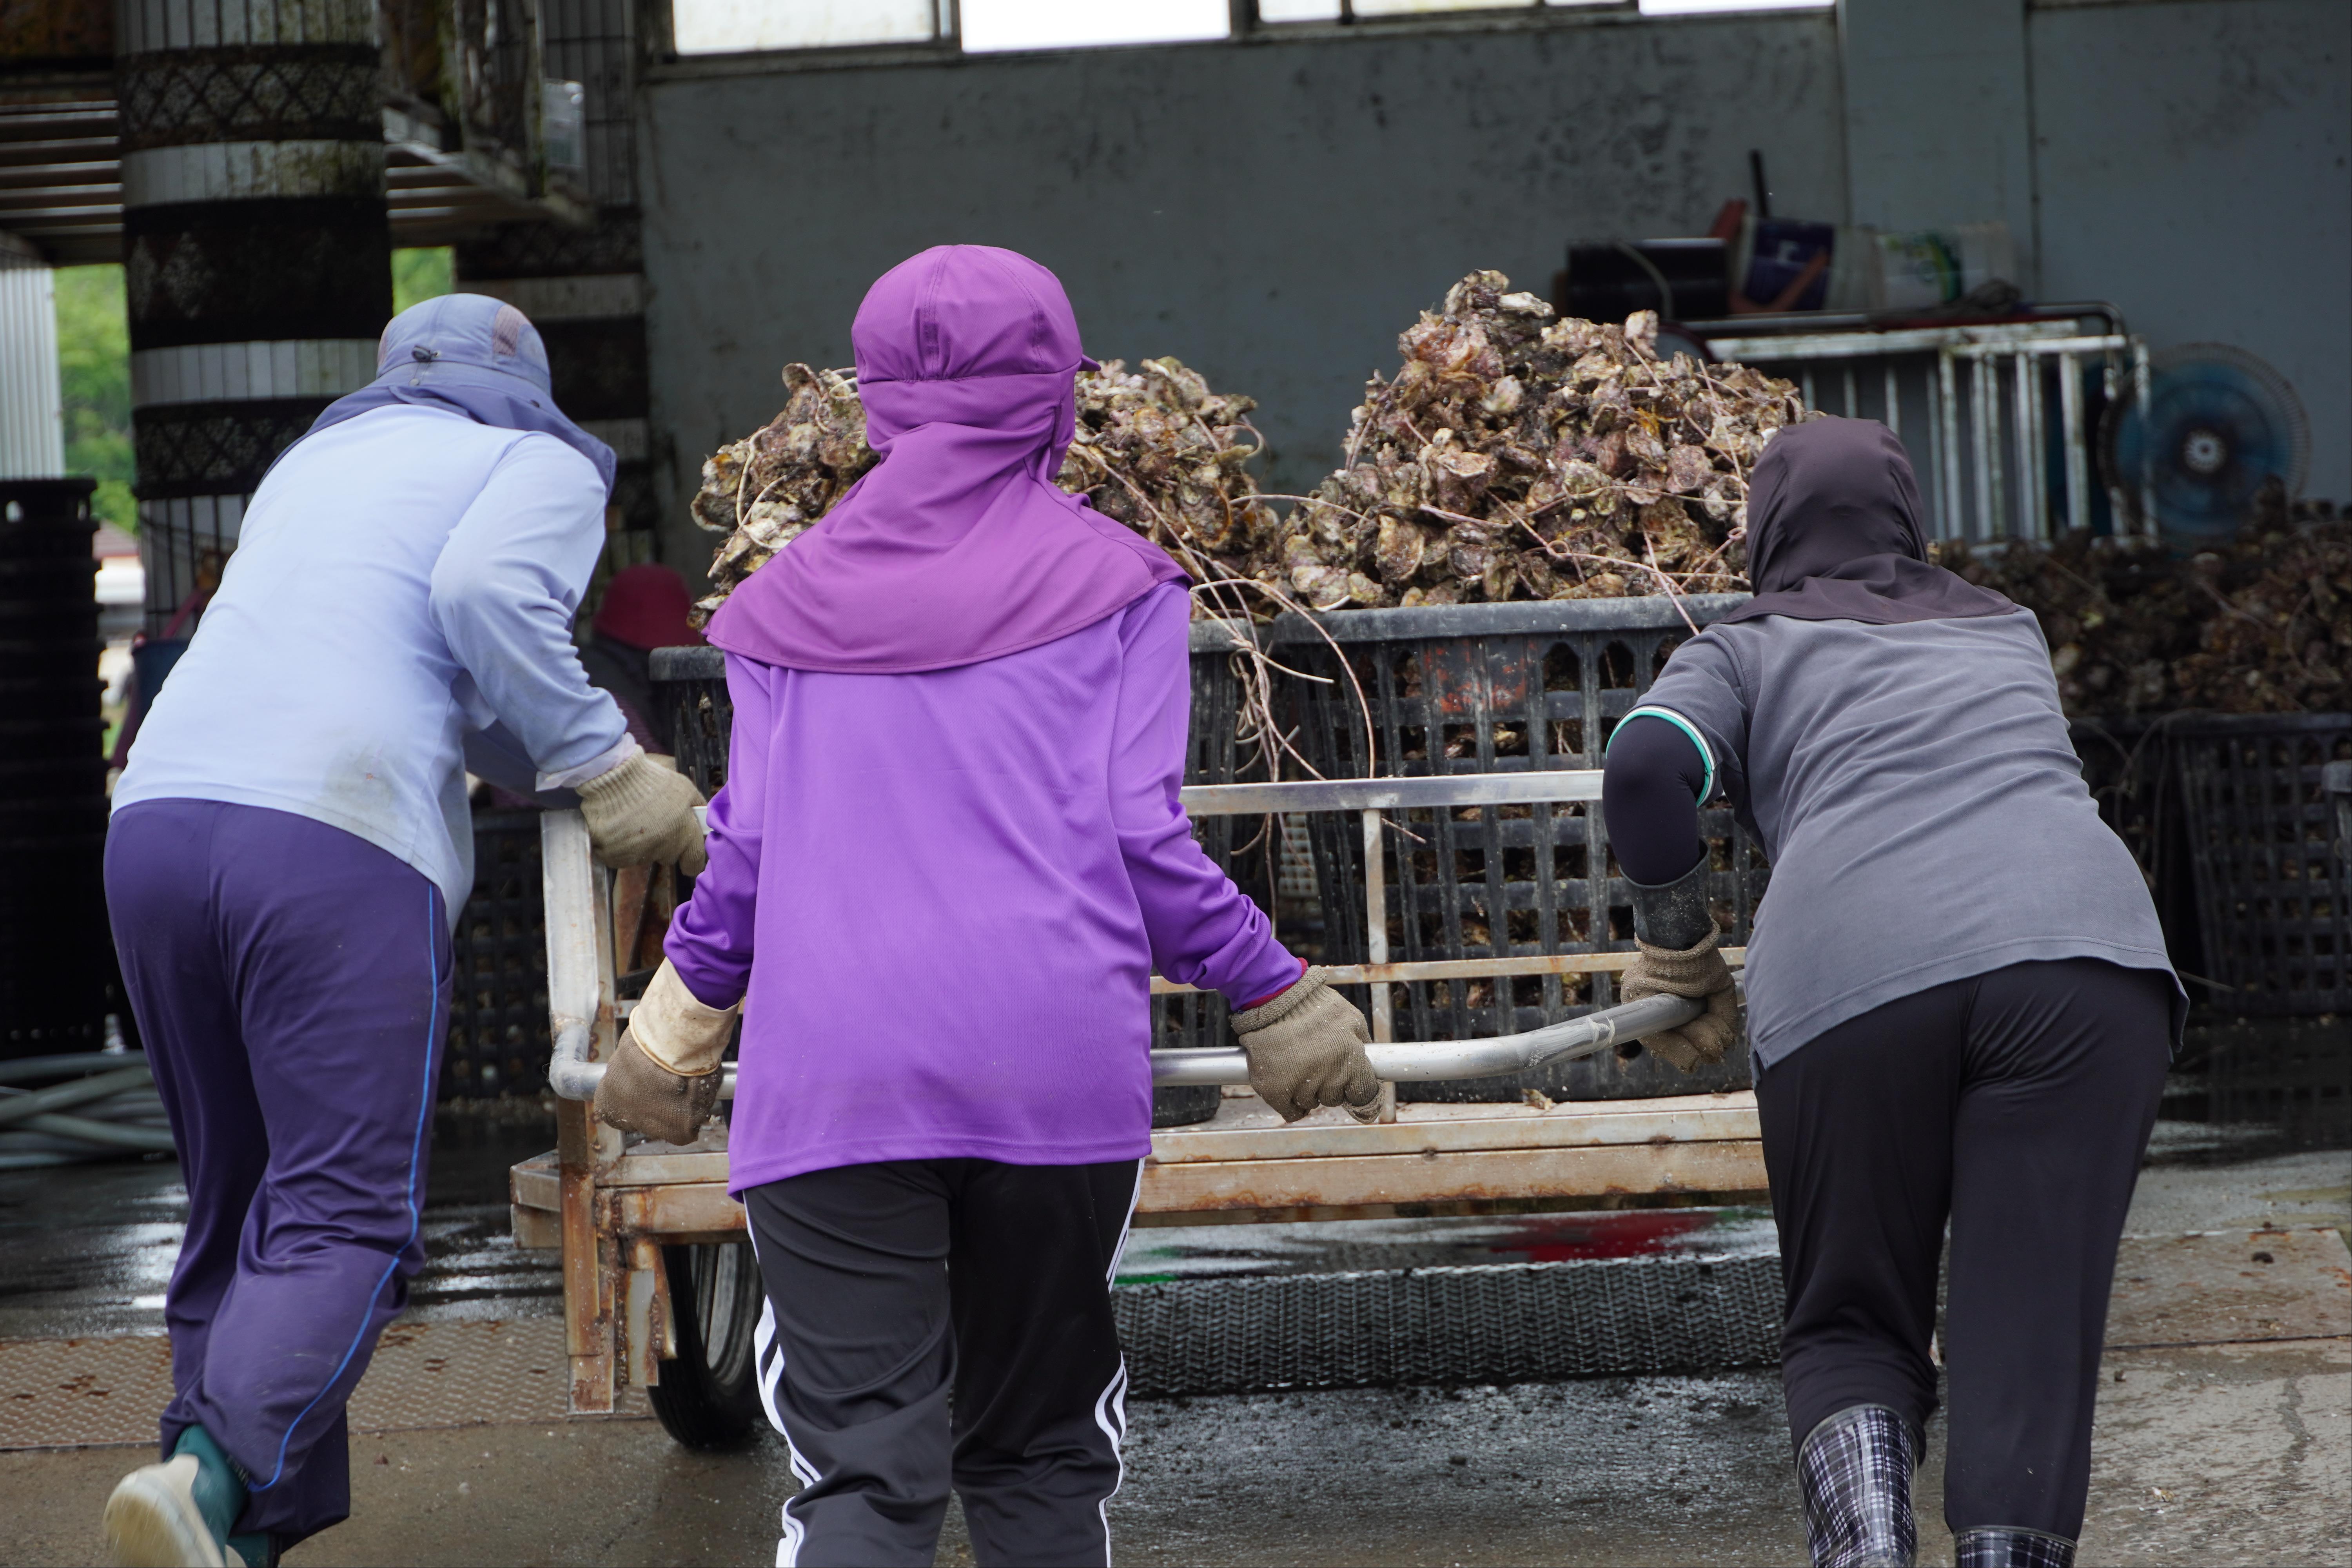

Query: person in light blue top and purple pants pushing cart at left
[103,294,701,1563]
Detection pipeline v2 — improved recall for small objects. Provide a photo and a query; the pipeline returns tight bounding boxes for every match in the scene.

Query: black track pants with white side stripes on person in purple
[743,1159,1138,1568]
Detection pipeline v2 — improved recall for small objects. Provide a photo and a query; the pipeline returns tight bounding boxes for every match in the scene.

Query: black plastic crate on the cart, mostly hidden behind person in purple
[652,621,1270,1126]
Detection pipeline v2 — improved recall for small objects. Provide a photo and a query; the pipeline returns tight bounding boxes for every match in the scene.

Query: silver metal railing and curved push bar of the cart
[539,769,1703,1100]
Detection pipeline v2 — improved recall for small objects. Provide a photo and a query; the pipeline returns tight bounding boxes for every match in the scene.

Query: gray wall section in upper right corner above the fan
[2032,0,2352,501]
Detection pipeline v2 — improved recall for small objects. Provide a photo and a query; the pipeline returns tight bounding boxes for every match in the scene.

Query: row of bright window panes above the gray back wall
[670,0,1832,54]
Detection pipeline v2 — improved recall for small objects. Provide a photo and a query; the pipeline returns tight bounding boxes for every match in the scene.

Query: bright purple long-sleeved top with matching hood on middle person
[668,247,1301,1192]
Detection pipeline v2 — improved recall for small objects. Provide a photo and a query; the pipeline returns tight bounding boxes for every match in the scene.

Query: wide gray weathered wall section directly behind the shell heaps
[640,12,1846,562]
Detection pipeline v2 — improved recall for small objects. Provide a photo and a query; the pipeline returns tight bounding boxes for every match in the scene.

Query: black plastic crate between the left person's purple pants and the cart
[440,811,555,1100]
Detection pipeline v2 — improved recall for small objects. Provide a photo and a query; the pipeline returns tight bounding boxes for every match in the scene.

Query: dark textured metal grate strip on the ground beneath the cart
[1112,1255,1780,1396]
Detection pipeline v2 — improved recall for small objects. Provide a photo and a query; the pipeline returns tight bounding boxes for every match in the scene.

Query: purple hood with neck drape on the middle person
[691,245,1183,675]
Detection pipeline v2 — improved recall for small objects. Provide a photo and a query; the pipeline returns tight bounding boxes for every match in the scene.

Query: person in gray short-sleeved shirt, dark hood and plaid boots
[1604,418,2185,1568]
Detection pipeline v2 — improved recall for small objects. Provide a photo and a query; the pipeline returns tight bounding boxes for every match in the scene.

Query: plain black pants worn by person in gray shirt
[1757,959,2173,1540]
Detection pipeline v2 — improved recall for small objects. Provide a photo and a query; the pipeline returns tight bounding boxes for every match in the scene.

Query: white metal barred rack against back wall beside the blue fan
[1708,306,2154,543]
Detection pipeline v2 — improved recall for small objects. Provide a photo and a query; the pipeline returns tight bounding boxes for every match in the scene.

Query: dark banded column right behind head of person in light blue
[456,0,663,576]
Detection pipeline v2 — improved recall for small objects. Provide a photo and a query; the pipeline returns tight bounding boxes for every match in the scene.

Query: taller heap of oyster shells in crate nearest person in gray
[1272,273,1806,609]
